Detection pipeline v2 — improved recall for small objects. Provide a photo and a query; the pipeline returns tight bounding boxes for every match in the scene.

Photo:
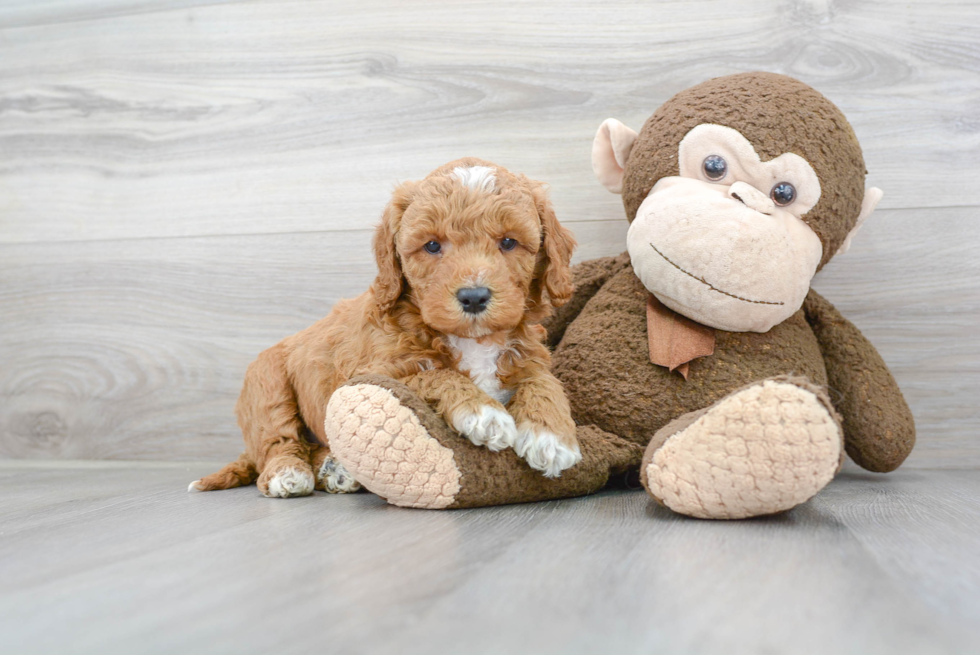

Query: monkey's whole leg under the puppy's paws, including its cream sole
[324,375,642,509]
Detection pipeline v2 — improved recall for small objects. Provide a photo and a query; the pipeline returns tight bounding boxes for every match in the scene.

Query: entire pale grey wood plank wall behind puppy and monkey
[0,0,980,468]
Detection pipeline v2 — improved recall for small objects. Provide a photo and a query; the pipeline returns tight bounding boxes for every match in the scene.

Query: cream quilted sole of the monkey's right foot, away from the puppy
[641,378,842,519]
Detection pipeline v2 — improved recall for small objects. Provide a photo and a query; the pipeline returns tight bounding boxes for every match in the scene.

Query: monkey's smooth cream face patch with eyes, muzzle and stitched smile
[627,124,823,332]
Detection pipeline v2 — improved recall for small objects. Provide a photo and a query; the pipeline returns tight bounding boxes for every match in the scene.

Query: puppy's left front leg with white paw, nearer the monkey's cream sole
[402,369,517,452]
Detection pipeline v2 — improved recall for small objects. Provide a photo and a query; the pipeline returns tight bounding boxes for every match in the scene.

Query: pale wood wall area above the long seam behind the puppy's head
[0,0,980,242]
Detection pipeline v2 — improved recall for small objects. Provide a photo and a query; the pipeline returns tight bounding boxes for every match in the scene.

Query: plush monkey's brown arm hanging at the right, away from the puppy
[803,289,915,473]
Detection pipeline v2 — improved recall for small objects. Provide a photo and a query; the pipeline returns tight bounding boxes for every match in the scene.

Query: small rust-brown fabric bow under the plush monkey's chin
[647,293,715,380]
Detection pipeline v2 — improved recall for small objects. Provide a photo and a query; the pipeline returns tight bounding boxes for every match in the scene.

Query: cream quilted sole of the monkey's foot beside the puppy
[324,384,460,509]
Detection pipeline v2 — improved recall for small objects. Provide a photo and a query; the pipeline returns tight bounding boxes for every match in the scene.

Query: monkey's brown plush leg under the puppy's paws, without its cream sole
[347,375,643,509]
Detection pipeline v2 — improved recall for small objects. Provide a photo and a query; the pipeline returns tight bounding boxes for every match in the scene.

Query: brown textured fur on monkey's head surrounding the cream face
[623,73,866,267]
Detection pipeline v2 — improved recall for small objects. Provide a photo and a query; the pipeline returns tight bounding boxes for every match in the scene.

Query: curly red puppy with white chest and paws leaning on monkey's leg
[191,158,581,498]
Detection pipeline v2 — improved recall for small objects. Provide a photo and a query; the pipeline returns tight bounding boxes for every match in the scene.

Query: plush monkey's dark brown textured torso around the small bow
[552,270,827,445]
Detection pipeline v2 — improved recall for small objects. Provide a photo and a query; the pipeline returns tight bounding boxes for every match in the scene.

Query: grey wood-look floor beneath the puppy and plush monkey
[0,463,980,655]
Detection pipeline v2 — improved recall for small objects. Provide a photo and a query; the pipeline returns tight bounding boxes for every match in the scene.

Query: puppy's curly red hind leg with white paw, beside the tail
[235,345,316,498]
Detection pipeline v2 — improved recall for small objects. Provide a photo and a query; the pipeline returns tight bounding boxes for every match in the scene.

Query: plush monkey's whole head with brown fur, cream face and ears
[593,74,881,332]
